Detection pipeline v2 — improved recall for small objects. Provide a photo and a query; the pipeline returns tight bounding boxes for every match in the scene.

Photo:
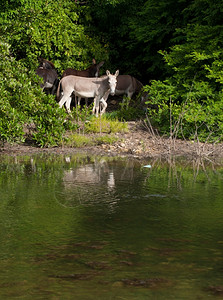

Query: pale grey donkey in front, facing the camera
[57,70,119,117]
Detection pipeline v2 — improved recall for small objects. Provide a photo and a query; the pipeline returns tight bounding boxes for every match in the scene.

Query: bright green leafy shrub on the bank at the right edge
[147,25,223,141]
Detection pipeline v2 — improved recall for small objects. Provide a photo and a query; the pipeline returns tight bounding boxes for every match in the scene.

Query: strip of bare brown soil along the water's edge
[0,122,223,160]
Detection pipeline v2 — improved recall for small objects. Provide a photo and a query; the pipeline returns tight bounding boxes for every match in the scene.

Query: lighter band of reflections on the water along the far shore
[0,154,222,207]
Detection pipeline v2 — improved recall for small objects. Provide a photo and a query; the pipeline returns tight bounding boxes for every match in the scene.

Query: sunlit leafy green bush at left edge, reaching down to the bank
[0,42,69,146]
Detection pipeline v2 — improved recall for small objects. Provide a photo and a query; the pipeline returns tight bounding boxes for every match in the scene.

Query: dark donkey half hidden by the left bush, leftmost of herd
[36,58,59,95]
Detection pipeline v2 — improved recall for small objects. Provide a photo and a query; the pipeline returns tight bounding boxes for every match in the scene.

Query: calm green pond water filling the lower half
[0,155,223,300]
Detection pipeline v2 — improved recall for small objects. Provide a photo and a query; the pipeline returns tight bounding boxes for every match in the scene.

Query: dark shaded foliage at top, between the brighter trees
[89,0,191,78]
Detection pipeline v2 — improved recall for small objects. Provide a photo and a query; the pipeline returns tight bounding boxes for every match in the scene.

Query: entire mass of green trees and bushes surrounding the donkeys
[0,0,223,146]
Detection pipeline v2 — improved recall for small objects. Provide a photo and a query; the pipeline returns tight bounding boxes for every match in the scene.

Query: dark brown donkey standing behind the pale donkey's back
[62,59,104,78]
